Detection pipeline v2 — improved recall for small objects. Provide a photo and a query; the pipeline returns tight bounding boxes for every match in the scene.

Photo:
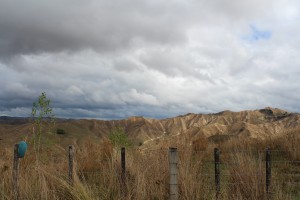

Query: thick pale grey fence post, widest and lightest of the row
[169,148,178,200]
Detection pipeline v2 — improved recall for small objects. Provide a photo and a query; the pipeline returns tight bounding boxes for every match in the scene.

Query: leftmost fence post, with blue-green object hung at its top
[13,144,19,200]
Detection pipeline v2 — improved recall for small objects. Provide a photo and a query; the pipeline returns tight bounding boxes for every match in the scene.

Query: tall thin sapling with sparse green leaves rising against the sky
[31,92,55,160]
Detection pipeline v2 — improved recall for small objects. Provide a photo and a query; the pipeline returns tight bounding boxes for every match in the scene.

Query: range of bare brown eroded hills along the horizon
[0,107,300,146]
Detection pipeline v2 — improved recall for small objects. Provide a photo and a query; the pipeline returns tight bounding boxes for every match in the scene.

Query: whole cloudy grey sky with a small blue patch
[0,0,300,119]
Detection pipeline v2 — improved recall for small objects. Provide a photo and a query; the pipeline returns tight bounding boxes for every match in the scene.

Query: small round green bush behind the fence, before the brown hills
[108,127,132,148]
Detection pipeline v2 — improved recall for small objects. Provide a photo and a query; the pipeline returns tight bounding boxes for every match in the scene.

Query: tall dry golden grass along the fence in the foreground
[0,131,300,200]
